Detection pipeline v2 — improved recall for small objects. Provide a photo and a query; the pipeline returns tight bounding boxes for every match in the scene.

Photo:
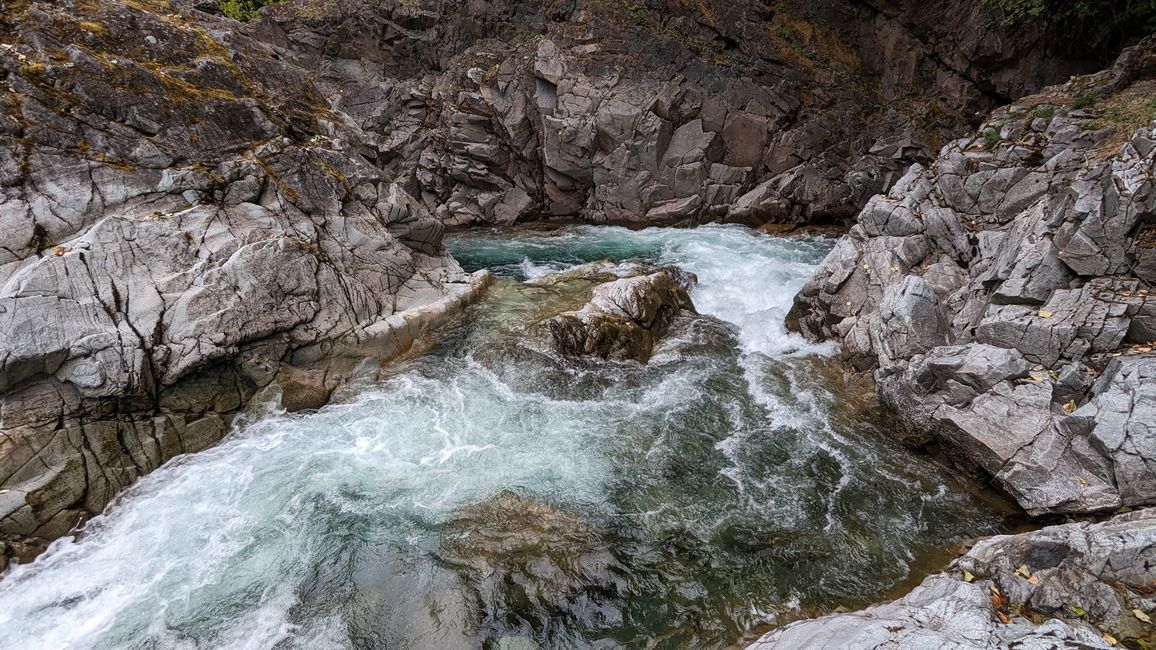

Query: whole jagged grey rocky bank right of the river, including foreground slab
[753,40,1156,649]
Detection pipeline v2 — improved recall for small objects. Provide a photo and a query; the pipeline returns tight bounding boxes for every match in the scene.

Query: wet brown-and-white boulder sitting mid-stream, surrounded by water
[539,263,696,362]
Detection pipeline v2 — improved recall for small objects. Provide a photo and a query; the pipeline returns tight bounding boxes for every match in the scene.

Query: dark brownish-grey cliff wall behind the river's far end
[252,0,1095,224]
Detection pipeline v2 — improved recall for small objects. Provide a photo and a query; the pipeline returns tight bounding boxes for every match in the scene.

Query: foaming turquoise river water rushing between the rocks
[0,227,1001,649]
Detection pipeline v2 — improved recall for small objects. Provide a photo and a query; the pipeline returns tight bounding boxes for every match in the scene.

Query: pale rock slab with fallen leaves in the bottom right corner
[748,509,1156,650]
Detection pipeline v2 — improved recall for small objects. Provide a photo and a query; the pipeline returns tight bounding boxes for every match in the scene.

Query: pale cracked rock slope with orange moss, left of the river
[0,1,483,561]
